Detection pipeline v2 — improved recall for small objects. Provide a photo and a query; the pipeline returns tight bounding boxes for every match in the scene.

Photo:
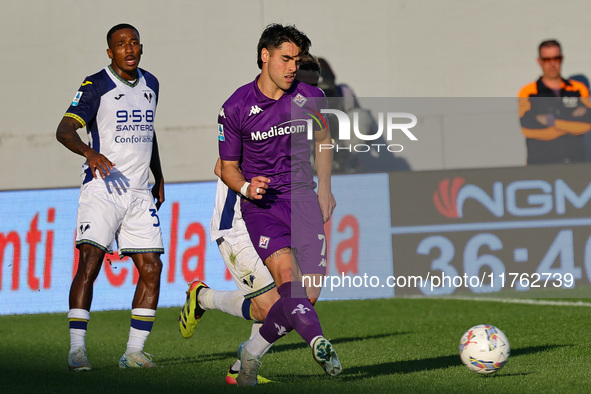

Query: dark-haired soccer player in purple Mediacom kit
[218,24,341,386]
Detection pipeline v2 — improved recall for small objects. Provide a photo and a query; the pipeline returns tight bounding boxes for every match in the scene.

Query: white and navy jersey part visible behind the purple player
[209,179,250,243]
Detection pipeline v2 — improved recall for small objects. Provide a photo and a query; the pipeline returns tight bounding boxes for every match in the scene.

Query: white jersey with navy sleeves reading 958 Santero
[65,66,159,190]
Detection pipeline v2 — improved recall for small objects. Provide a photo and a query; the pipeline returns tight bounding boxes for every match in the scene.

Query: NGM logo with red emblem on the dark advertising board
[433,177,591,219]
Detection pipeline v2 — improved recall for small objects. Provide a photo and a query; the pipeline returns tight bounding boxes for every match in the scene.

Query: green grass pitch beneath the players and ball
[0,298,591,394]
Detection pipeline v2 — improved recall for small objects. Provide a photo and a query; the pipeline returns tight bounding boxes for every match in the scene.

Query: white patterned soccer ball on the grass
[460,324,511,375]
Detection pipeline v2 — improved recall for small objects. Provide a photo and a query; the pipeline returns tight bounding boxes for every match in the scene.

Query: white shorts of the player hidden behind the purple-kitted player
[218,234,275,300]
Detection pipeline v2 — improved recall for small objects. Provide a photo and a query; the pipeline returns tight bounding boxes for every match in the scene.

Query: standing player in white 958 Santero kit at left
[56,24,164,371]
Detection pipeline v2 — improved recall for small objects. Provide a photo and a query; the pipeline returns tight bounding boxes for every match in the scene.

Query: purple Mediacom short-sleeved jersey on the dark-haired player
[218,77,326,201]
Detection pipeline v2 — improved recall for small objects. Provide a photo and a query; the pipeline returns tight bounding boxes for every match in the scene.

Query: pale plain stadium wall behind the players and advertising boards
[0,0,591,190]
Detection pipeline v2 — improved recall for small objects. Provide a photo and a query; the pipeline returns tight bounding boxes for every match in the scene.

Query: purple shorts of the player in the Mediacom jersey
[241,199,326,275]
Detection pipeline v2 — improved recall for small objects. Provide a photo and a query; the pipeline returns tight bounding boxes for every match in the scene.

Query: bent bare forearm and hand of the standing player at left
[55,116,115,178]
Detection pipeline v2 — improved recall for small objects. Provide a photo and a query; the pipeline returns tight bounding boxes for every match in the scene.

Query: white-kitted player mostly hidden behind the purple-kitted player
[178,159,279,384]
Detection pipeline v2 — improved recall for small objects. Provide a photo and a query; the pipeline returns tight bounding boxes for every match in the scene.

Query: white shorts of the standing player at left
[76,185,164,256]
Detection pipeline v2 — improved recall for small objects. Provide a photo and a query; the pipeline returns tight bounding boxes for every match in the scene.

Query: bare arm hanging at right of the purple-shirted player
[315,129,337,223]
